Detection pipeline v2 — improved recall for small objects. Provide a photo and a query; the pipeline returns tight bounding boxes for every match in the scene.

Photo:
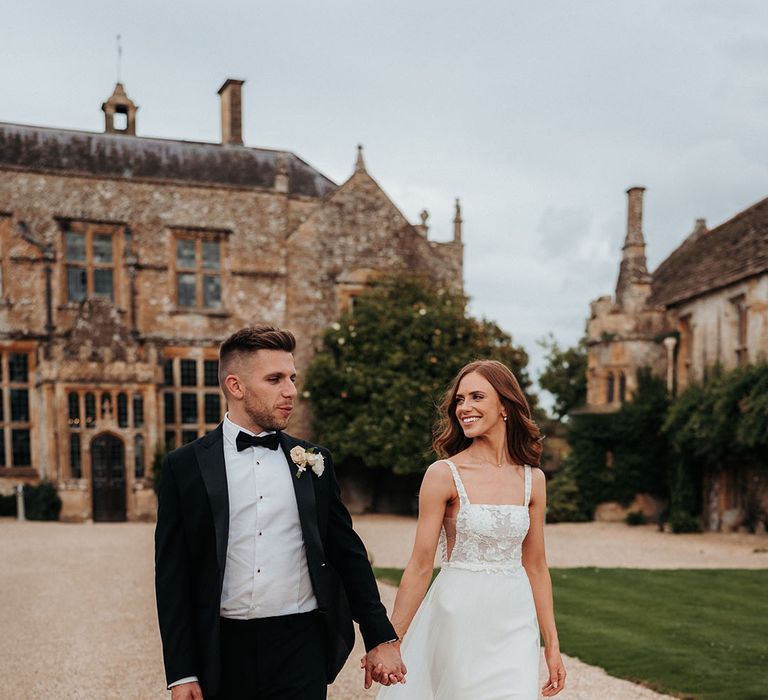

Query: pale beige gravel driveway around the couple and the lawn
[0,516,768,700]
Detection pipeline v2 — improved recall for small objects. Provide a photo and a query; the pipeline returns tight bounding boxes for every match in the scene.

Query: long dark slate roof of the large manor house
[0,123,336,197]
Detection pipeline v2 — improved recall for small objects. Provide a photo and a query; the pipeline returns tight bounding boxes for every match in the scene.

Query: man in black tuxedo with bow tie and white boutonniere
[155,326,405,700]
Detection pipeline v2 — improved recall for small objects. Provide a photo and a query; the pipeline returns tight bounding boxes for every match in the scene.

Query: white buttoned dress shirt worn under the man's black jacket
[168,413,317,688]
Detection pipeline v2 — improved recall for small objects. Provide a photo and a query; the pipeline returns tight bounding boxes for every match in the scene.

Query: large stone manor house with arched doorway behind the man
[0,79,463,520]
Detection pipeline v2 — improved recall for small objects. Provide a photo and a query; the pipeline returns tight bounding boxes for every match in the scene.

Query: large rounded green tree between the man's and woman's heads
[305,275,533,474]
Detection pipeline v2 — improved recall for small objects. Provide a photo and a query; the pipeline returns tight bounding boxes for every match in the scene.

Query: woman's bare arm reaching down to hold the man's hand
[392,462,456,639]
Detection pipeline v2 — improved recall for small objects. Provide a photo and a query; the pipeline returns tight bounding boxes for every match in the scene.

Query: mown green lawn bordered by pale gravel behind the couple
[375,568,768,700]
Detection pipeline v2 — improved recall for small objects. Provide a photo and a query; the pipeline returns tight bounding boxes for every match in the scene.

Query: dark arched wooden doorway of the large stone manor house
[91,433,125,522]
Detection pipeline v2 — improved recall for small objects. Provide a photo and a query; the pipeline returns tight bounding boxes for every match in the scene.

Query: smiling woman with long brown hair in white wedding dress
[363,360,565,700]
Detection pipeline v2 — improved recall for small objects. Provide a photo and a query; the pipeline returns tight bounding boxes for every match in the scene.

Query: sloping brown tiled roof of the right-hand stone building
[650,198,768,306]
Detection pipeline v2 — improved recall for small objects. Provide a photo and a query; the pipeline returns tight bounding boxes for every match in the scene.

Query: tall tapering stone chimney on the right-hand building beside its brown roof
[616,187,651,310]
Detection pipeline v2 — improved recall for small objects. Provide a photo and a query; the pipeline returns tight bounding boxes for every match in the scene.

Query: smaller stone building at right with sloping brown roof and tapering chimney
[585,187,768,530]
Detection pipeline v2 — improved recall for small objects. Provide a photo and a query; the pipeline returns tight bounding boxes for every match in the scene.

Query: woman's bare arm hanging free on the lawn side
[523,469,565,697]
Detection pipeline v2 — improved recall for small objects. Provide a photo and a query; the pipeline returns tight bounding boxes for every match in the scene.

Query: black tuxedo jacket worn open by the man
[155,425,397,695]
